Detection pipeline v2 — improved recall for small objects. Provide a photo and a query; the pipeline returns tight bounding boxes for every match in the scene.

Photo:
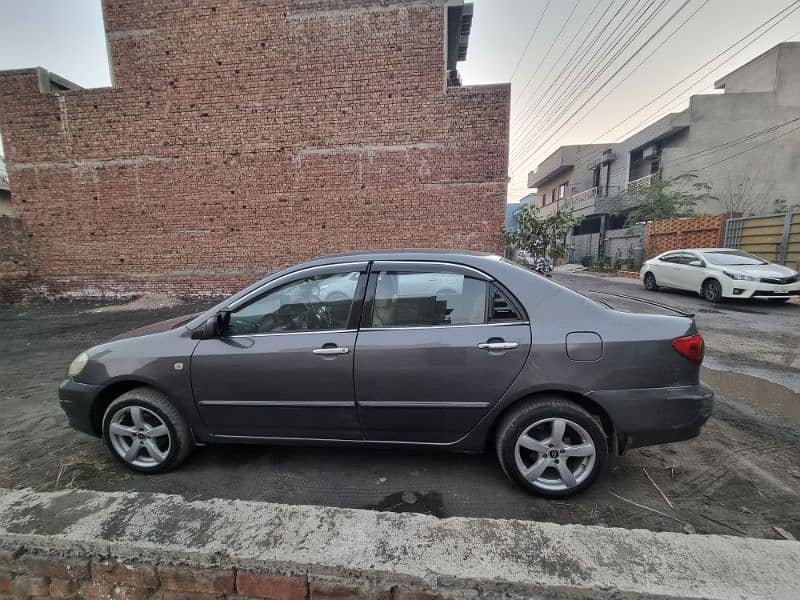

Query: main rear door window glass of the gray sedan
[372,271,488,327]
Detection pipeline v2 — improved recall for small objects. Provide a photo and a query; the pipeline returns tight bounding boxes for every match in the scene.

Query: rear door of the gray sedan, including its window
[355,261,531,443]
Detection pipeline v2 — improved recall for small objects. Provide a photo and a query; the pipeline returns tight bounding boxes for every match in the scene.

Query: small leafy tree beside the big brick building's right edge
[503,203,580,260]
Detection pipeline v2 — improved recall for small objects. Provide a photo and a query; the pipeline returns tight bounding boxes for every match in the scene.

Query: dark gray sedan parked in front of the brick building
[59,250,713,497]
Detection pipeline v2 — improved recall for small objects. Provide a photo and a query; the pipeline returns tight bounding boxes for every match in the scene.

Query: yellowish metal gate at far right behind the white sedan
[725,210,800,269]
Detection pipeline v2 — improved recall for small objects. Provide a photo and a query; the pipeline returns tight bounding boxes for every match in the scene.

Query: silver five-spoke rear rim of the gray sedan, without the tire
[514,418,596,491]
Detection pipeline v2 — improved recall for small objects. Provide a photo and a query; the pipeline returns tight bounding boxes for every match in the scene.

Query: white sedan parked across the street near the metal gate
[639,248,800,302]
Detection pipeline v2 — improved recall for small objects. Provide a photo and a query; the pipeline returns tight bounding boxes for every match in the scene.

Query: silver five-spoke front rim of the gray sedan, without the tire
[108,405,172,468]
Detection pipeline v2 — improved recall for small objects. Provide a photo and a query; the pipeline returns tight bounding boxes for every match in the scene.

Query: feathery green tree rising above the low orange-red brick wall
[611,172,717,227]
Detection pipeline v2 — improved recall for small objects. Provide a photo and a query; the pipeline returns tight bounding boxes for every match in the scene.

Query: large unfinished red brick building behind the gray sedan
[0,0,509,296]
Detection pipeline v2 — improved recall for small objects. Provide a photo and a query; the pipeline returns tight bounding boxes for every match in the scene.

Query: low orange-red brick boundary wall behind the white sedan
[645,215,728,258]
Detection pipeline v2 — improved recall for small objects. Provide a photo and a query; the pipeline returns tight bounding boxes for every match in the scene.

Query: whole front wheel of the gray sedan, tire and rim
[103,387,194,473]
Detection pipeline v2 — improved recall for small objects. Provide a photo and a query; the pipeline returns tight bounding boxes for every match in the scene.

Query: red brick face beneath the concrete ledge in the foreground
[0,550,450,600]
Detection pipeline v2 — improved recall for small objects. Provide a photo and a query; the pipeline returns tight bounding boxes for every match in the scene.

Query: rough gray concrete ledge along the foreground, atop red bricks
[0,490,800,600]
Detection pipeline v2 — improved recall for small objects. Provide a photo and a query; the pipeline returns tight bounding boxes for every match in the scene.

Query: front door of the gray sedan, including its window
[191,262,368,439]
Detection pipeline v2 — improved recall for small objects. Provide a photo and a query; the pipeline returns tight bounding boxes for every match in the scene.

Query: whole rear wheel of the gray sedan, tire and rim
[495,397,608,498]
